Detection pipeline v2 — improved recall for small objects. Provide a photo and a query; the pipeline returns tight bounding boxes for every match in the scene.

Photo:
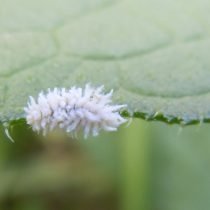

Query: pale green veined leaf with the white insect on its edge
[0,0,210,124]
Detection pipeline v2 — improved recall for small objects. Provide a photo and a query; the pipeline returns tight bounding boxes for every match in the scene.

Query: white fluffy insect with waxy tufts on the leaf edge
[24,84,127,138]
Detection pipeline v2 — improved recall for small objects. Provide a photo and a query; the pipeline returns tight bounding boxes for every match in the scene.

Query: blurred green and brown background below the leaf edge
[0,120,210,210]
